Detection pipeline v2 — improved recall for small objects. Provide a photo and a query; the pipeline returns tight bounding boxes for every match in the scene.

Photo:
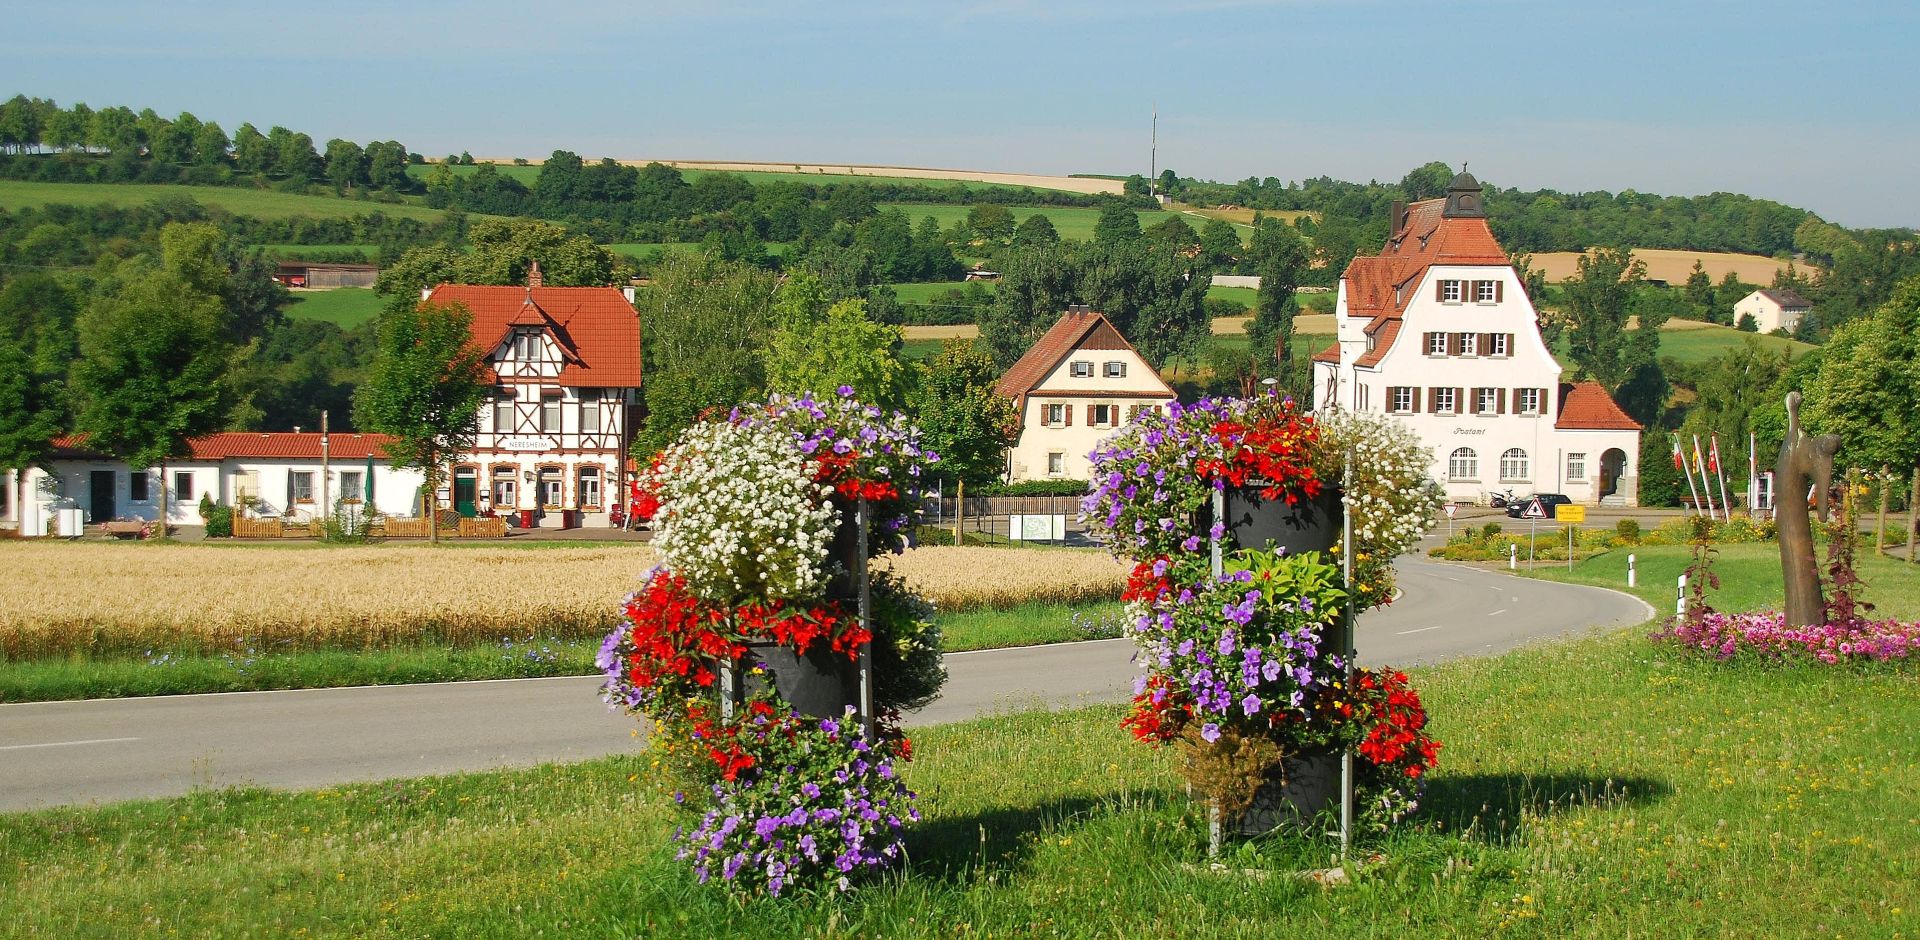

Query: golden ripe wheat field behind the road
[0,541,1125,660]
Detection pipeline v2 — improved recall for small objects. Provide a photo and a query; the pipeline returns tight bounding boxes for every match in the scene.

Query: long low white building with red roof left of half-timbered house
[0,432,424,535]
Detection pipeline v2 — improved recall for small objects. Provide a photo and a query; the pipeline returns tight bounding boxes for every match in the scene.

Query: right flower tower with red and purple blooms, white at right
[1083,395,1440,844]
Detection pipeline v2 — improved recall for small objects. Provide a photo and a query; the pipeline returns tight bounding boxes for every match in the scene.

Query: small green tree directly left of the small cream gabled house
[916,340,1020,483]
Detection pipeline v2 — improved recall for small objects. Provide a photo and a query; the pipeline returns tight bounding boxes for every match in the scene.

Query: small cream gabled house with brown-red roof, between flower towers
[995,305,1175,483]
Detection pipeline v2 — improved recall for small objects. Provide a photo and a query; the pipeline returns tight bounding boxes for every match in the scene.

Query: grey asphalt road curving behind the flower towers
[0,558,1653,810]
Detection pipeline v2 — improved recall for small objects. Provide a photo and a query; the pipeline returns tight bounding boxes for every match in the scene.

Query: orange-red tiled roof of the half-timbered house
[428,284,639,388]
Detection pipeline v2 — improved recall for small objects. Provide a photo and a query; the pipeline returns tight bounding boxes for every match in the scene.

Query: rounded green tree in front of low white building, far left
[73,261,230,531]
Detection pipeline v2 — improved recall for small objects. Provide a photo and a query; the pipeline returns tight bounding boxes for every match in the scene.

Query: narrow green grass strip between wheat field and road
[0,600,1119,702]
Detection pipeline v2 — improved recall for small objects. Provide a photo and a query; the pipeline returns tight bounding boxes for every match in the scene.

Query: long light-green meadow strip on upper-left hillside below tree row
[0,180,444,223]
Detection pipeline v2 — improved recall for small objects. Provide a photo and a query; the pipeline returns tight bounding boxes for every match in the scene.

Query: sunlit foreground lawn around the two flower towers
[0,631,1920,938]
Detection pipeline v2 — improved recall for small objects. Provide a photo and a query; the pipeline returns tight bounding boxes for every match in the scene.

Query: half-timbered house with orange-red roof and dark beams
[420,265,639,528]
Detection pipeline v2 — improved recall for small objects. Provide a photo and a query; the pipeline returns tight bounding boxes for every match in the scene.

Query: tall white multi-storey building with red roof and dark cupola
[1313,173,1640,505]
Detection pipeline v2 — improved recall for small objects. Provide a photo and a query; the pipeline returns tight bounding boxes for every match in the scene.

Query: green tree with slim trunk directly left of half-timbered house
[353,303,488,541]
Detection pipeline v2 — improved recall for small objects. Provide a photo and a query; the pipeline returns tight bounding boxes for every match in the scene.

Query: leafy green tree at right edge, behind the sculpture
[1805,276,1920,468]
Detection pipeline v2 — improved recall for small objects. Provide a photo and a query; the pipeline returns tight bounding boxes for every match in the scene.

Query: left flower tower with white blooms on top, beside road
[597,395,947,894]
